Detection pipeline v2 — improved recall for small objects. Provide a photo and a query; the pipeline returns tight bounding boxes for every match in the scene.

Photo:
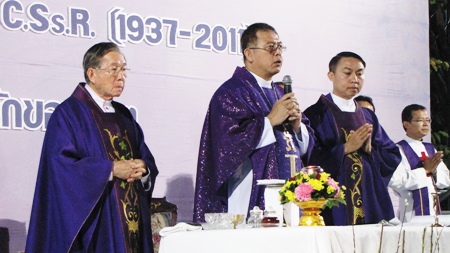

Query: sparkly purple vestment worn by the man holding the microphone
[194,67,313,222]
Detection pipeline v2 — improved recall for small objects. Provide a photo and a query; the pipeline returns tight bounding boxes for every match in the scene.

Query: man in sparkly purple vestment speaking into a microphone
[194,23,313,222]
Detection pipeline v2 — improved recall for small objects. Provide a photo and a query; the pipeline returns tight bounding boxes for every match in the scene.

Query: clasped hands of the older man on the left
[112,159,147,182]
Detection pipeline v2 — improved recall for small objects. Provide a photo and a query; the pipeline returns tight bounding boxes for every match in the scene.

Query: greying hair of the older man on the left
[83,42,120,83]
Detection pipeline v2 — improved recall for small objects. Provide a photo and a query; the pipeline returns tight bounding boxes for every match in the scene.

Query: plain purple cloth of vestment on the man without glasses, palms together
[305,94,401,225]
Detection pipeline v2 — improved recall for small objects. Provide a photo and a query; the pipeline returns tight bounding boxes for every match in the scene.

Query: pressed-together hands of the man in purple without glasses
[344,123,373,154]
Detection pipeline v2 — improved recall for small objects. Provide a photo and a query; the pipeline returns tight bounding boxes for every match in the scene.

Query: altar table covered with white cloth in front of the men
[159,224,450,253]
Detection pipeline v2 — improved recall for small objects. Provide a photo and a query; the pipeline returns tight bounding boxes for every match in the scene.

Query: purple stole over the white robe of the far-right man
[397,140,441,216]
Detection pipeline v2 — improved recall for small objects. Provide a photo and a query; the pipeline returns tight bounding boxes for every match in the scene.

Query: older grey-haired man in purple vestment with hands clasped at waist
[25,42,158,253]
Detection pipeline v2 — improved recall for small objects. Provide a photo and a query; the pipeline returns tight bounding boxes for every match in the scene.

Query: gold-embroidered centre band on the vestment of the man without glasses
[322,97,366,224]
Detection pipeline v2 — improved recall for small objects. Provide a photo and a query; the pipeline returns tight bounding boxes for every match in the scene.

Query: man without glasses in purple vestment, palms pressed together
[305,52,401,225]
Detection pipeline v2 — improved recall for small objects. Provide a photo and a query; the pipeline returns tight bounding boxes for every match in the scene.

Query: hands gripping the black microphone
[267,92,302,133]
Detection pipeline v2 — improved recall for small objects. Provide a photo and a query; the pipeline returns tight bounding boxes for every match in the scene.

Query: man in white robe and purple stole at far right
[389,104,450,222]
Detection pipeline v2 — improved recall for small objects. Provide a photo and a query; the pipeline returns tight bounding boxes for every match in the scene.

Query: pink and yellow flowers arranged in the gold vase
[279,166,346,208]
